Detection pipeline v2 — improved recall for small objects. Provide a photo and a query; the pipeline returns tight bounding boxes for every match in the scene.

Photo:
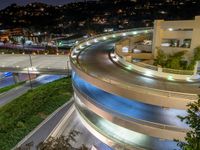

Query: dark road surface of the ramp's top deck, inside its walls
[79,39,200,94]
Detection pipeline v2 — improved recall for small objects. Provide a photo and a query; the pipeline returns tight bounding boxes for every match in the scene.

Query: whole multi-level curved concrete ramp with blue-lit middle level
[71,30,200,149]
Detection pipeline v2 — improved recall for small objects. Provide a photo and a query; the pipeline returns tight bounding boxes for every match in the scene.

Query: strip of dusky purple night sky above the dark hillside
[0,0,83,9]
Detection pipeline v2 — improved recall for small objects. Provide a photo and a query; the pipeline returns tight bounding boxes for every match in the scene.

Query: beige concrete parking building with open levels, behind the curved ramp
[152,16,200,58]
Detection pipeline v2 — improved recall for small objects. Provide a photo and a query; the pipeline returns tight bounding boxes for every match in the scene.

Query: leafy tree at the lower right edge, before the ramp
[176,98,200,150]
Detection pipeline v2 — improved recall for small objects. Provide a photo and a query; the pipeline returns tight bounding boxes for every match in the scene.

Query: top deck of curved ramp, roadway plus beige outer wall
[72,38,200,109]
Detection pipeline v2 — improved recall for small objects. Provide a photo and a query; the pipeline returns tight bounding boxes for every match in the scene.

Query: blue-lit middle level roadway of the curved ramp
[73,72,188,128]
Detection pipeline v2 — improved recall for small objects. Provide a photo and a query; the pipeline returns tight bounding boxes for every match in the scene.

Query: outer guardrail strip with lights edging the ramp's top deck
[70,28,198,101]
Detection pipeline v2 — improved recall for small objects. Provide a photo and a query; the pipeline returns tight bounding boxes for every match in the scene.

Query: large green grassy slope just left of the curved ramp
[0,78,73,150]
